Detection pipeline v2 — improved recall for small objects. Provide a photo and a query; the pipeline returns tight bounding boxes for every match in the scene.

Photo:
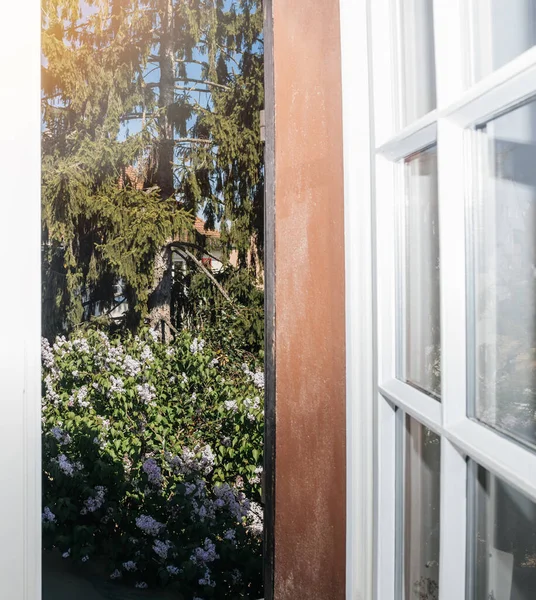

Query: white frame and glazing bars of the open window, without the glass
[340,0,536,600]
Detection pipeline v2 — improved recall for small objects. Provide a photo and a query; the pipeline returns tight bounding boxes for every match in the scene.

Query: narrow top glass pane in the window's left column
[400,0,436,125]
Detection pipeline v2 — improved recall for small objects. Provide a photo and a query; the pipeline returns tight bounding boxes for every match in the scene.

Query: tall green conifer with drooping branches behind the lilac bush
[42,0,263,335]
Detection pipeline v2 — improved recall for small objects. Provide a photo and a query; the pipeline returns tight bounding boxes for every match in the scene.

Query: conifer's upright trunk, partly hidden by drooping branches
[149,0,175,339]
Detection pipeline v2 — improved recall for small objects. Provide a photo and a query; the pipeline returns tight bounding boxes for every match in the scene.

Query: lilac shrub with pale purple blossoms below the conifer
[42,330,264,600]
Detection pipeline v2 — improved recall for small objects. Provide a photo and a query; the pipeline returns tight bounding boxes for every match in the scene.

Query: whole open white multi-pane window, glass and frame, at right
[342,0,536,600]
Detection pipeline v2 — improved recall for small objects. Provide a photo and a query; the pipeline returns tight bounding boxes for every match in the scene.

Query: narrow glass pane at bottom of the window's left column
[404,416,441,600]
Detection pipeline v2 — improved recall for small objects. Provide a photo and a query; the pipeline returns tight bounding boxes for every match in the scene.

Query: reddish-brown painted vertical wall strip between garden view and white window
[266,0,346,600]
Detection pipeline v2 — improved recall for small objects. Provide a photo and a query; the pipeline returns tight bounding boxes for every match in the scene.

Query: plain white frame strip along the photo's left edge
[0,0,42,600]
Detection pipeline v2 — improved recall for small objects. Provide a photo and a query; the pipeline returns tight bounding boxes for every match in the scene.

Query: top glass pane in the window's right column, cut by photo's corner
[473,0,536,81]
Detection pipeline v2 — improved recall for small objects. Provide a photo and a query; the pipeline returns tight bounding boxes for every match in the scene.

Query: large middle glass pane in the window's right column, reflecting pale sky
[469,102,536,443]
